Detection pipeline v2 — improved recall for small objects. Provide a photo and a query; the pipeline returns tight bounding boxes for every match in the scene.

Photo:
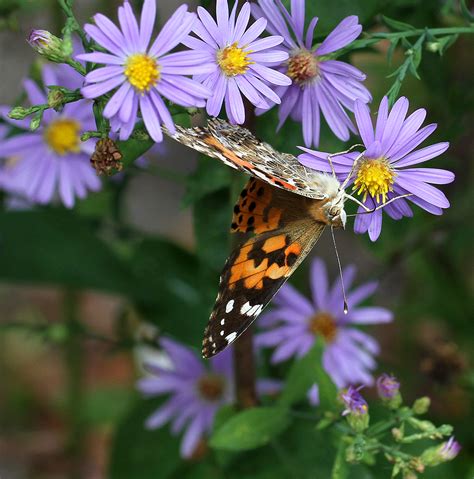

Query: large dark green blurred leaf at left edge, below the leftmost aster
[0,209,131,295]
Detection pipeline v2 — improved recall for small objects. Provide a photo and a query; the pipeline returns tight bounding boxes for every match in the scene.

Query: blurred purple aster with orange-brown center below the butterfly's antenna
[256,258,392,388]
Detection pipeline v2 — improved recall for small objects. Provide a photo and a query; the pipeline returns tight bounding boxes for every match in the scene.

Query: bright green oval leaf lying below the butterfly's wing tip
[210,407,290,451]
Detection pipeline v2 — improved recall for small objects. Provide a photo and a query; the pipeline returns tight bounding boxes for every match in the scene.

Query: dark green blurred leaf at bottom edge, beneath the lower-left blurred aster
[107,401,182,479]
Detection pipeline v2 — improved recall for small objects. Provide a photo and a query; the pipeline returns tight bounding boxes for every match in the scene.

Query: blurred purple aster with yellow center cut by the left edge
[0,65,101,208]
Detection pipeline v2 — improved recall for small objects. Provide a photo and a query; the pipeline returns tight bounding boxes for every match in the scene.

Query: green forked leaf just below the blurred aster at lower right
[279,341,337,410]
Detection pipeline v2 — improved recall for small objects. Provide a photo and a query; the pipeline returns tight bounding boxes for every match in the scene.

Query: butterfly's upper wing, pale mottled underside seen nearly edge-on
[164,118,322,199]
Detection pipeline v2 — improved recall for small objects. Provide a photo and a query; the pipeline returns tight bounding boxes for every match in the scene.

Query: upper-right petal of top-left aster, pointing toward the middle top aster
[149,5,197,57]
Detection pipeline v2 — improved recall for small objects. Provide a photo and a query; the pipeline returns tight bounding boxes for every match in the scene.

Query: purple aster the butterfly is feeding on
[299,97,454,241]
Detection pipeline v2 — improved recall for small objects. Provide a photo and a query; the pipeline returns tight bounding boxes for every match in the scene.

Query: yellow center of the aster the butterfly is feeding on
[354,158,395,203]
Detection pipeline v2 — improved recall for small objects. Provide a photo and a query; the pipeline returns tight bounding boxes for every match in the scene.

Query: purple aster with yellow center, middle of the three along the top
[183,0,291,124]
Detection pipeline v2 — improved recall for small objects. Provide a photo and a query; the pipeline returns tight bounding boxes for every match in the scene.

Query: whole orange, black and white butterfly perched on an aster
[166,119,392,358]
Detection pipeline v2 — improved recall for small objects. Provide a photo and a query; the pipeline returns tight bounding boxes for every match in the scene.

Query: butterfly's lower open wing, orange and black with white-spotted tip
[202,179,325,358]
